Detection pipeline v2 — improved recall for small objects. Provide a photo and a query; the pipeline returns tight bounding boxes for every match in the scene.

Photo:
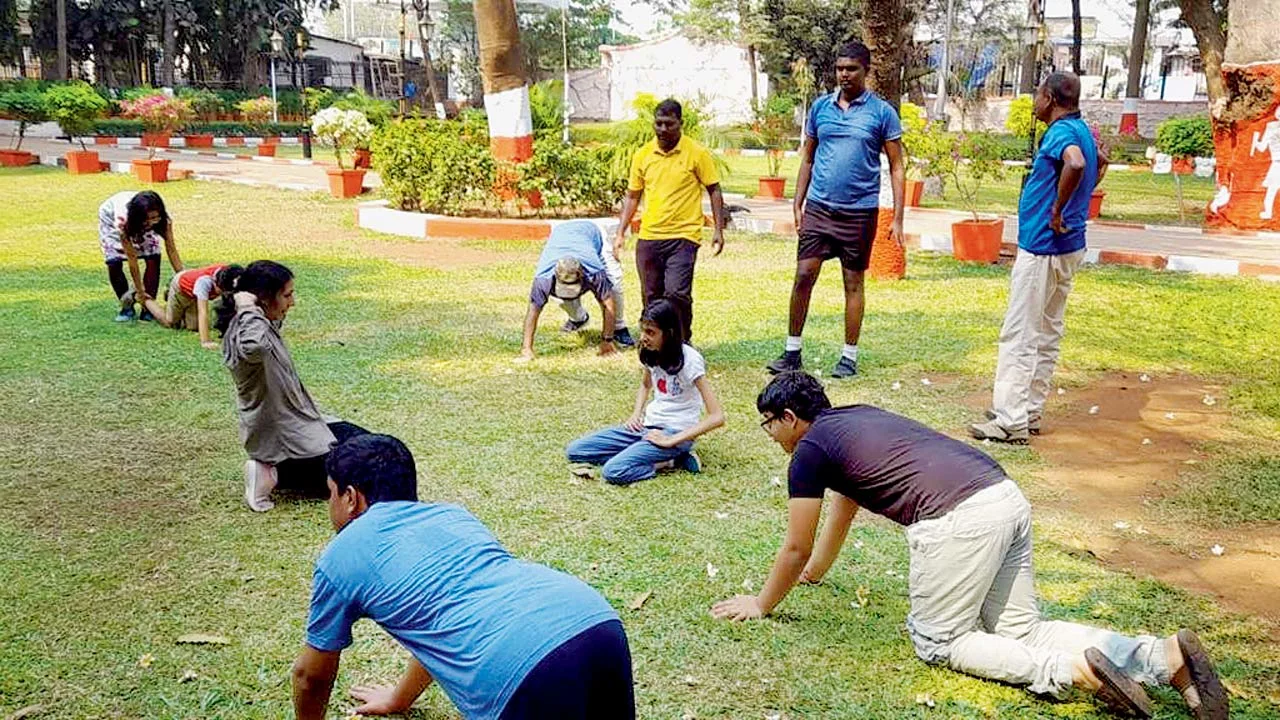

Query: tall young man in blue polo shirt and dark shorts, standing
[768,42,906,378]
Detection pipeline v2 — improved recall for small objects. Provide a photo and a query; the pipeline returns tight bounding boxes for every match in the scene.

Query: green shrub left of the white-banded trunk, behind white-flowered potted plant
[371,119,495,214]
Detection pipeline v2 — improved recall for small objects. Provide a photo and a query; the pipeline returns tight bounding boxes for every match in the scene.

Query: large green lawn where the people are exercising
[0,168,1280,720]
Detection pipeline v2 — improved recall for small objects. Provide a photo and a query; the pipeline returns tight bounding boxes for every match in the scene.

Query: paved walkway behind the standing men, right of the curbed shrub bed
[724,197,1280,265]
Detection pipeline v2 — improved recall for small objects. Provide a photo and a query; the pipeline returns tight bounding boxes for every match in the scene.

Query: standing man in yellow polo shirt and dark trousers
[613,100,724,341]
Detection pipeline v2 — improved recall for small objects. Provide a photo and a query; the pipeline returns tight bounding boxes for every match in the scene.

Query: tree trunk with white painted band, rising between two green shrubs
[474,0,534,163]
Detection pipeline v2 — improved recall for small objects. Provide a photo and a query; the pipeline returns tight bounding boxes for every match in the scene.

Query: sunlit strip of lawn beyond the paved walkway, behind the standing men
[723,156,1215,225]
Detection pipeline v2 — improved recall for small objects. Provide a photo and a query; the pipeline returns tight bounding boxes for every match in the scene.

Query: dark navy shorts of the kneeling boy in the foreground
[502,620,636,720]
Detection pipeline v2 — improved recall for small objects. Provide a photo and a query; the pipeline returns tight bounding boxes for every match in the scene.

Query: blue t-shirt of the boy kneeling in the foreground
[307,502,618,720]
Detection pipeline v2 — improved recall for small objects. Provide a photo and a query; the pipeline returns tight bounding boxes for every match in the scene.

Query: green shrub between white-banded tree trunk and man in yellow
[516,137,626,215]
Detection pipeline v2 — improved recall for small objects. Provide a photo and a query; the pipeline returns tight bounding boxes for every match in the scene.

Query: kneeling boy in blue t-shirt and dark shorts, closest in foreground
[293,434,635,720]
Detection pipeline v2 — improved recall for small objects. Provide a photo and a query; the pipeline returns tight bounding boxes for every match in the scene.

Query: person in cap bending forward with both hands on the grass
[516,220,635,363]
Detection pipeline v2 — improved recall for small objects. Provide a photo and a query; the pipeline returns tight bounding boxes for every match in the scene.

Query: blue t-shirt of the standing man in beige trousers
[1018,113,1098,255]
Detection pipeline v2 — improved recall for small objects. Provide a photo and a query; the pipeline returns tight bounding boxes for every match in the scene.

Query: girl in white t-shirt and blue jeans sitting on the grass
[566,299,724,486]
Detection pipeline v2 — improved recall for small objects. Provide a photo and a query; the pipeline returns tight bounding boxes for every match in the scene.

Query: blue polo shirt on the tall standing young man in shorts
[805,90,902,210]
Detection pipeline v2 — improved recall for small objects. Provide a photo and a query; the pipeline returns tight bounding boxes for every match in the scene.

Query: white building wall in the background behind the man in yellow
[600,35,769,124]
